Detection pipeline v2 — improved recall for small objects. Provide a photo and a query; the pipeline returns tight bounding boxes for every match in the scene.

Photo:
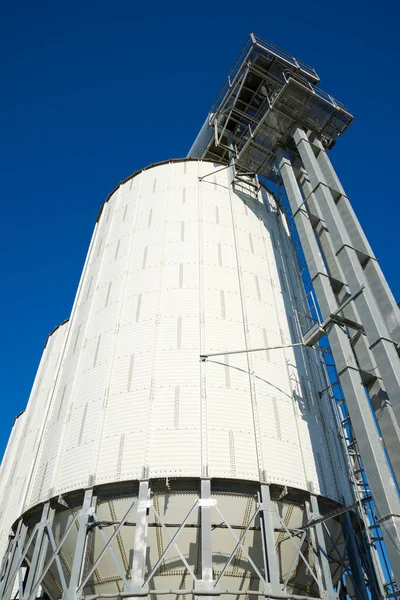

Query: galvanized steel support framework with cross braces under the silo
[0,479,379,600]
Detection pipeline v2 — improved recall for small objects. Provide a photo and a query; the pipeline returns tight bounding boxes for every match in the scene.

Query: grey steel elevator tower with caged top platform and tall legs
[189,34,400,596]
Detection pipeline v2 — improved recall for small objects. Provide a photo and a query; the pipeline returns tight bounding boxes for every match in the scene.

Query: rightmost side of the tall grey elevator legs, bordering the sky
[310,136,400,343]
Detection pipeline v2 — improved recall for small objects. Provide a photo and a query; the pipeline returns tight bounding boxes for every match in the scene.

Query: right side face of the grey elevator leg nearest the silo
[300,170,400,484]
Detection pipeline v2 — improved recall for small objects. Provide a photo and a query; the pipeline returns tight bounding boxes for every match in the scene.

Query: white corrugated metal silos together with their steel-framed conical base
[0,159,357,600]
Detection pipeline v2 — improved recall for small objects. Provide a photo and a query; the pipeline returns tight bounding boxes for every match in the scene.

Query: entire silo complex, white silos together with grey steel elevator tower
[0,35,400,600]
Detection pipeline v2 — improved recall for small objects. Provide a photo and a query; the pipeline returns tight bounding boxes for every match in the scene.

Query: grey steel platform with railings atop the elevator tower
[189,33,353,177]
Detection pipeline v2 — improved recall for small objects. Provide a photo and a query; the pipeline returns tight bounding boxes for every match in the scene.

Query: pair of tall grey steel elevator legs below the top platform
[278,134,400,582]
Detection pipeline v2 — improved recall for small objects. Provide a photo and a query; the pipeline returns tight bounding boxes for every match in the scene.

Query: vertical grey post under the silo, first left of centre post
[124,481,150,596]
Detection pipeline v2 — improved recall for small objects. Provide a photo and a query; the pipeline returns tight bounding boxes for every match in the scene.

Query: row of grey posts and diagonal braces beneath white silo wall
[0,479,390,600]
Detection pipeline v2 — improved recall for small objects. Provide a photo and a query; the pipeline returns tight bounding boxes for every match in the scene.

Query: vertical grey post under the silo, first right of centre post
[260,484,282,594]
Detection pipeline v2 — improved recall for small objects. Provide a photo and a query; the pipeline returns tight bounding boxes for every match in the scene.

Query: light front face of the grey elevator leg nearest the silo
[279,148,400,583]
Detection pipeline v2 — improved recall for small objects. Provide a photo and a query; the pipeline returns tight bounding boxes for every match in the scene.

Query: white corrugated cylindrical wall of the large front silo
[0,161,345,528]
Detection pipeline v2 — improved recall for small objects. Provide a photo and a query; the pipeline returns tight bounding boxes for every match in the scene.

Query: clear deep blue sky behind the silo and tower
[0,0,400,456]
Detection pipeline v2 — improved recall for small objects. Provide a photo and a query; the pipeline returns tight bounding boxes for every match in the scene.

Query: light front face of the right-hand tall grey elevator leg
[293,126,400,432]
